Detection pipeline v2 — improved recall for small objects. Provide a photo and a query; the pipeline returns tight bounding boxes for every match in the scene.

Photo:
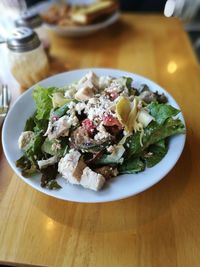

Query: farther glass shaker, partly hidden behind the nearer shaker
[15,11,50,53]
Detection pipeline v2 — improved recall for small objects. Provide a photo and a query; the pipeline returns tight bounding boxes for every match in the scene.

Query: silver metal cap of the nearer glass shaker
[7,27,41,52]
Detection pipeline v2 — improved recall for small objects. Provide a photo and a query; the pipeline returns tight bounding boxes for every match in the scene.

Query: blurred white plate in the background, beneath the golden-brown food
[44,12,120,37]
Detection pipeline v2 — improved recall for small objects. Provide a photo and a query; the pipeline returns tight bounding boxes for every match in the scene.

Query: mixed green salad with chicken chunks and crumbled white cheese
[16,72,185,191]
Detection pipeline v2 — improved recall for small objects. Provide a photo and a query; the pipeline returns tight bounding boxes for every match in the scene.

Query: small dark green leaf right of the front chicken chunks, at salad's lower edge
[118,157,145,174]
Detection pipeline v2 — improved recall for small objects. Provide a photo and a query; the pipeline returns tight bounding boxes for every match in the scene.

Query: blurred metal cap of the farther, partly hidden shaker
[15,11,43,29]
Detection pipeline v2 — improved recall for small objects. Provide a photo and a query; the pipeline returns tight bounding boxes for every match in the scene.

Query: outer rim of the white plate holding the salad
[2,68,187,203]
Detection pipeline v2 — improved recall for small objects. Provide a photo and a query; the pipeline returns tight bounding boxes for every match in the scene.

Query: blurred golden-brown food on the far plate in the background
[42,0,119,26]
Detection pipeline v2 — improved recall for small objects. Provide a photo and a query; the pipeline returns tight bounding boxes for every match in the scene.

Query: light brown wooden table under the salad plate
[0,14,200,267]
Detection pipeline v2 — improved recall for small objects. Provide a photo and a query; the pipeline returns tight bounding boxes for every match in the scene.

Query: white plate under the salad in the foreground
[2,69,185,202]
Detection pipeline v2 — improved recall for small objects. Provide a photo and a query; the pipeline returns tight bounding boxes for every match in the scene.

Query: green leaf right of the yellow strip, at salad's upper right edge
[147,102,180,124]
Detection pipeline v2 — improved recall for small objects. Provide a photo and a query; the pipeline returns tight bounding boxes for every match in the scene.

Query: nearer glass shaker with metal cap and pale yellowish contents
[7,27,49,89]
